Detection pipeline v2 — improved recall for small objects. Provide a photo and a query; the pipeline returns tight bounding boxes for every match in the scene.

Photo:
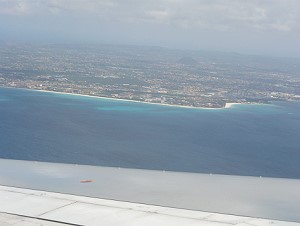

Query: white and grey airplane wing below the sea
[0,159,300,226]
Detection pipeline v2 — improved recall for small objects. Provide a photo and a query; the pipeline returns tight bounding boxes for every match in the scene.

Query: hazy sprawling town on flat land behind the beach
[0,44,300,108]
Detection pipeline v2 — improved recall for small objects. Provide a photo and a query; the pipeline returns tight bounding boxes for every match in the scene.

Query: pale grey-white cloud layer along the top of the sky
[0,0,300,32]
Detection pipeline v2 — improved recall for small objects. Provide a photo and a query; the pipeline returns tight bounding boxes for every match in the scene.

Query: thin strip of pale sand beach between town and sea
[3,87,243,110]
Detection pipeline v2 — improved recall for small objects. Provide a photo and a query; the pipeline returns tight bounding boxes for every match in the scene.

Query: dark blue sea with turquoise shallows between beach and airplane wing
[0,88,300,178]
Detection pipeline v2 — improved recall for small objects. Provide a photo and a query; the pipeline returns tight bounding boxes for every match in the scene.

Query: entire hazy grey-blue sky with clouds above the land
[0,0,300,57]
